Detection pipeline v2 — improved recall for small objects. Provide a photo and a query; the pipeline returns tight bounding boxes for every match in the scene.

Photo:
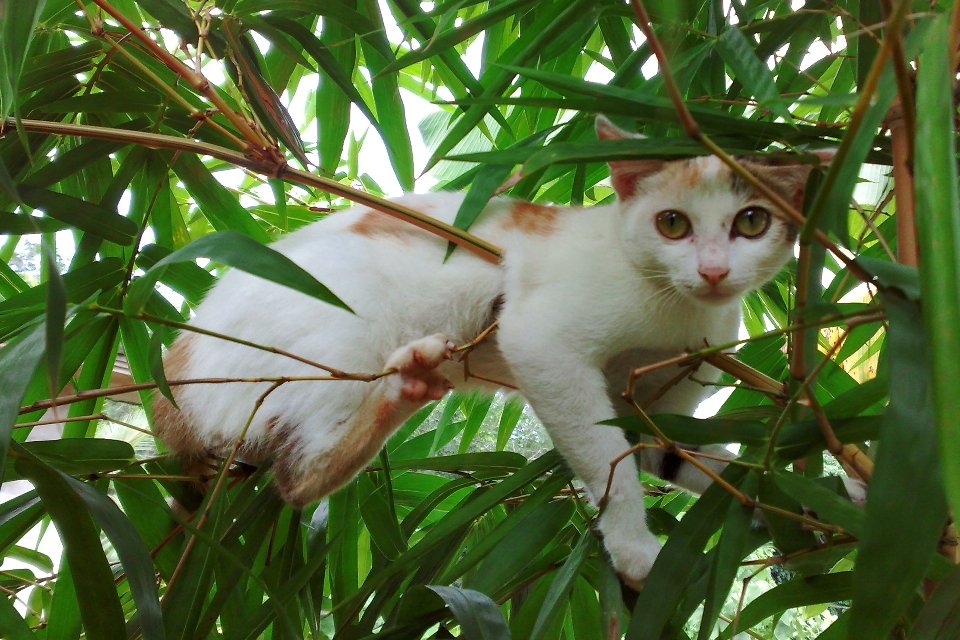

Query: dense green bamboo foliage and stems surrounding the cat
[0,0,960,640]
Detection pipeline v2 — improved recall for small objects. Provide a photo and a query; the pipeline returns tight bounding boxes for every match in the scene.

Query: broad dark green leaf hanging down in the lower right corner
[850,295,947,640]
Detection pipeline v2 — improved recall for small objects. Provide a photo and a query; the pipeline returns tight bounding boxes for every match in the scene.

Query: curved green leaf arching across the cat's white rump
[127,231,353,313]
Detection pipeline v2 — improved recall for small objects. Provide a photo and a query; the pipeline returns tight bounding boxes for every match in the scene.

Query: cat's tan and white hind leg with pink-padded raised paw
[271,334,456,506]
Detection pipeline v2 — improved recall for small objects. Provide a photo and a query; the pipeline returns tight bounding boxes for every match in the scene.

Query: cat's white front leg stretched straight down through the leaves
[500,342,660,588]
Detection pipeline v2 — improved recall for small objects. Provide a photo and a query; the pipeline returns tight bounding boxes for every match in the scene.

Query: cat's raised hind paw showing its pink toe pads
[387,333,456,402]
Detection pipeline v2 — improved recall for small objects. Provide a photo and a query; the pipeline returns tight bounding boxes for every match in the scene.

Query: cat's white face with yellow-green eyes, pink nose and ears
[596,116,829,305]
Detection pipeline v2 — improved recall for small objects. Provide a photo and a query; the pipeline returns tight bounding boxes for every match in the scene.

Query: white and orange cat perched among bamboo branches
[153,116,824,585]
